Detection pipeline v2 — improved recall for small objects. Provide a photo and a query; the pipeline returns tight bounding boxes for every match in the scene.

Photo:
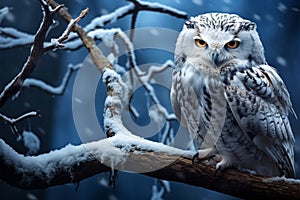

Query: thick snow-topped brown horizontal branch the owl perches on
[0,136,300,199]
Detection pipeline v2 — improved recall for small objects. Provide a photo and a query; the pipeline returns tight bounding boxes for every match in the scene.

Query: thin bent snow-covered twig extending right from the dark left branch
[23,63,82,95]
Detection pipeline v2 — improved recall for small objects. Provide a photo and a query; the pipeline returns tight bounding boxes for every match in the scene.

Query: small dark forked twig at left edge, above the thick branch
[0,111,41,136]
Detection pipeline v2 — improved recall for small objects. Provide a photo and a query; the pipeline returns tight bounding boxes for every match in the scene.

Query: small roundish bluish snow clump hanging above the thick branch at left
[22,130,40,155]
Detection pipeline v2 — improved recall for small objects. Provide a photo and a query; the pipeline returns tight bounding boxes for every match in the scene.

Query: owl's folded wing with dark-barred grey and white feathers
[221,62,295,177]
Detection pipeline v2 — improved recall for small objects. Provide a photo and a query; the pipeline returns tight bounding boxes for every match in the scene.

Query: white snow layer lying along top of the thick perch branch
[0,130,185,184]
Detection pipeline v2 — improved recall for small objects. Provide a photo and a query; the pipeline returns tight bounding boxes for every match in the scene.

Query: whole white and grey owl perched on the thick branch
[171,13,295,177]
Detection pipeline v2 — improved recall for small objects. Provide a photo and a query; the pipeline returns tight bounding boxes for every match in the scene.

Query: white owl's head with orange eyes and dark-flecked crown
[175,13,266,68]
